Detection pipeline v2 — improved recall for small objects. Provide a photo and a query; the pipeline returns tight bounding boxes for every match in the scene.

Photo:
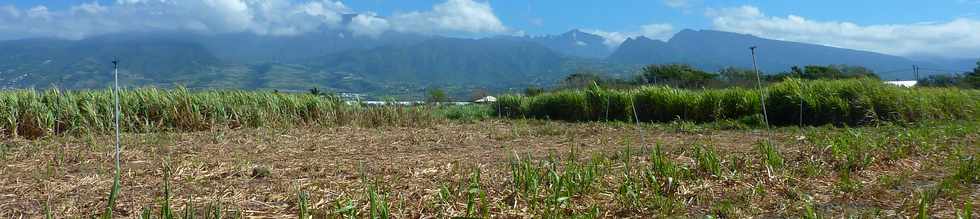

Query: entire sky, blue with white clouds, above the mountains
[0,0,980,58]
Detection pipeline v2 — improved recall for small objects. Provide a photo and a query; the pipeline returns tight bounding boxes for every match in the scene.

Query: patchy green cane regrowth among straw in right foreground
[47,122,978,218]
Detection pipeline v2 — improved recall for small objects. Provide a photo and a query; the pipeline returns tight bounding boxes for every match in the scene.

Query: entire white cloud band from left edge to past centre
[0,0,513,39]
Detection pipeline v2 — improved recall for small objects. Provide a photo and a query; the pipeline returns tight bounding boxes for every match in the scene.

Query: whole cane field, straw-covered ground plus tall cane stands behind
[0,74,980,218]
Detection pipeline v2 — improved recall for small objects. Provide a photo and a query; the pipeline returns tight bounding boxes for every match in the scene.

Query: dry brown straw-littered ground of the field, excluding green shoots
[0,121,980,218]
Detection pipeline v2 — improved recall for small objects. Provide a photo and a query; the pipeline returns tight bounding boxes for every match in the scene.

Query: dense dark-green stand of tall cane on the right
[494,79,980,125]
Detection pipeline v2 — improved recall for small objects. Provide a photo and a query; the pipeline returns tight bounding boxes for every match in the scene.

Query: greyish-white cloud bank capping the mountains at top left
[0,0,351,39]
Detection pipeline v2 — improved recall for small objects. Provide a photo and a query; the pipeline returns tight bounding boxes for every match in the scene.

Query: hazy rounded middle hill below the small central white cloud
[309,38,565,85]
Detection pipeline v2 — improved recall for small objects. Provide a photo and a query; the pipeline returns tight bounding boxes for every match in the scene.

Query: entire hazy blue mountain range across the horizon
[0,27,975,95]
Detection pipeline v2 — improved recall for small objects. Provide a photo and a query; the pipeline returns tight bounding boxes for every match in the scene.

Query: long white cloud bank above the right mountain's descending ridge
[705,6,980,58]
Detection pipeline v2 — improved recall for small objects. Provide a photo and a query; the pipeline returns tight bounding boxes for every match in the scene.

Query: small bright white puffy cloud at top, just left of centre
[389,0,508,33]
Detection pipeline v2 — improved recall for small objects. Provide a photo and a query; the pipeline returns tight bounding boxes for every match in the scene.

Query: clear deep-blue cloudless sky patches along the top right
[345,0,980,34]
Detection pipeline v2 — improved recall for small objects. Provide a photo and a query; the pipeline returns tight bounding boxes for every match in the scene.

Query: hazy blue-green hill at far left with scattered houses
[0,37,223,88]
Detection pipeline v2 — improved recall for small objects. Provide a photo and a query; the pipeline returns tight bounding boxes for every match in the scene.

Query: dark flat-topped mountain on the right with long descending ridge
[608,30,932,79]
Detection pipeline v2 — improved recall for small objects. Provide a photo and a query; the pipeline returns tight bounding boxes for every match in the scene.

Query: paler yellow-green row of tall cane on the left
[0,88,436,138]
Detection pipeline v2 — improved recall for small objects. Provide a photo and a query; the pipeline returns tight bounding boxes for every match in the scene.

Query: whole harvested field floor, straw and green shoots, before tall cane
[0,116,980,218]
